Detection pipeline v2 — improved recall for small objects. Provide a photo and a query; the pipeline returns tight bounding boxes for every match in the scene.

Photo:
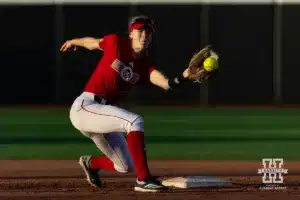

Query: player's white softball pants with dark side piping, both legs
[70,92,144,173]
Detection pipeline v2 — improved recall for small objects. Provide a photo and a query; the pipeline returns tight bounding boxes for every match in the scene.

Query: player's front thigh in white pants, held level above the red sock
[71,100,144,133]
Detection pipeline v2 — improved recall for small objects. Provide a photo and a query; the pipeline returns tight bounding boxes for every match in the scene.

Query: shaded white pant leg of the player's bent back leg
[89,132,133,172]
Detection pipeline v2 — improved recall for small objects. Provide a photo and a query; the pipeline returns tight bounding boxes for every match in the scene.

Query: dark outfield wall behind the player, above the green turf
[0,4,300,105]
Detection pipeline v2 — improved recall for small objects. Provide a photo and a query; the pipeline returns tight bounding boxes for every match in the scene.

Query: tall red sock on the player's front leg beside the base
[127,131,150,181]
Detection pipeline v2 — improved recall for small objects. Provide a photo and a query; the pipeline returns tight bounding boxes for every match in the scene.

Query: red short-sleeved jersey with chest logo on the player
[84,34,155,103]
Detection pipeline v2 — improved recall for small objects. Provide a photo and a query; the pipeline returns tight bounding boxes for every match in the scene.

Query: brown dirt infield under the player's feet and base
[0,160,300,200]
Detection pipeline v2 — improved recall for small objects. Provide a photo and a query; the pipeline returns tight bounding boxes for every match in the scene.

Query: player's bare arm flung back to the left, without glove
[60,37,103,52]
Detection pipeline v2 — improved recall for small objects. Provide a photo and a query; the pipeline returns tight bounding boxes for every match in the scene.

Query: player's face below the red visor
[130,29,152,52]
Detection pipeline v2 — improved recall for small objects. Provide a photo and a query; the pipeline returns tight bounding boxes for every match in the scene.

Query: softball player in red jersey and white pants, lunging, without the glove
[61,16,188,192]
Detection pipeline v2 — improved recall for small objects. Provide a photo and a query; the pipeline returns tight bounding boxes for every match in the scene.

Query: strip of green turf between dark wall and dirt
[0,107,300,160]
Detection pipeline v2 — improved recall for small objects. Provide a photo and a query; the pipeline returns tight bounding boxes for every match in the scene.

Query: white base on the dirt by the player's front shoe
[162,176,231,188]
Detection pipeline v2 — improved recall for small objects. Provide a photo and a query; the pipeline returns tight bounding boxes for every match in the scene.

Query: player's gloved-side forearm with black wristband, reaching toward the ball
[150,69,189,90]
